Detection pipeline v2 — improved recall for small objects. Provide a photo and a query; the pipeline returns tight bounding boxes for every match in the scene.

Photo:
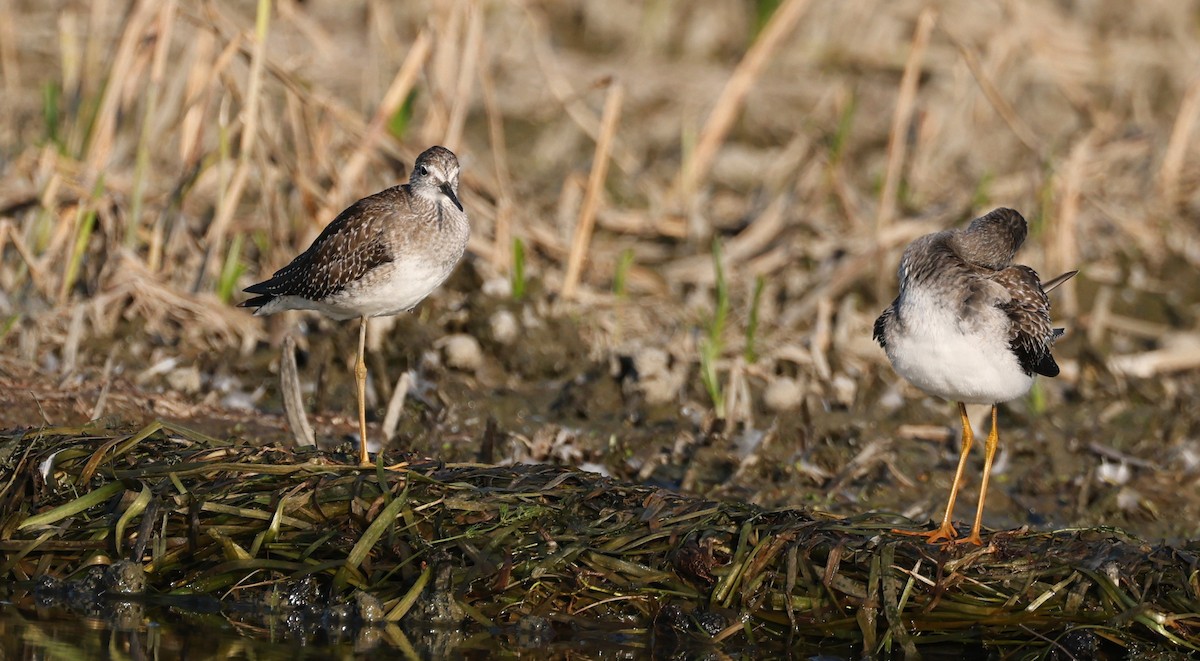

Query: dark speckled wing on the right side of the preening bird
[991,265,1058,377]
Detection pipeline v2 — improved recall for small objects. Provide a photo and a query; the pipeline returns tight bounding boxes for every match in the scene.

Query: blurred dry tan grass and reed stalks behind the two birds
[0,1,1200,395]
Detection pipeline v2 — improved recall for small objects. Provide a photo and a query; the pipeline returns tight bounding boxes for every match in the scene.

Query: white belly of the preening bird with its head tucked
[887,299,1033,404]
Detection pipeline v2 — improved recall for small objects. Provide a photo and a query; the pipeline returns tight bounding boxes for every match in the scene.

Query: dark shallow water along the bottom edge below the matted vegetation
[0,601,986,661]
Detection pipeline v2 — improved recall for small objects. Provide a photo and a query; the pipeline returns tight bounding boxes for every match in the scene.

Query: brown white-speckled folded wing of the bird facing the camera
[246,188,402,305]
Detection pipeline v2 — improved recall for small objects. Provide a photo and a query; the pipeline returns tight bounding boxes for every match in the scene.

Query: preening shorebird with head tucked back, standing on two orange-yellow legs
[874,209,1076,545]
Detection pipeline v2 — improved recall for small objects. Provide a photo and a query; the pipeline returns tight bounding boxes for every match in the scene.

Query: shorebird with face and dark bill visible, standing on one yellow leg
[240,146,470,464]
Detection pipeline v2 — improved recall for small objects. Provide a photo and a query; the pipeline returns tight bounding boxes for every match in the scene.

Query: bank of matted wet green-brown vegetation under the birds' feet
[0,423,1200,655]
